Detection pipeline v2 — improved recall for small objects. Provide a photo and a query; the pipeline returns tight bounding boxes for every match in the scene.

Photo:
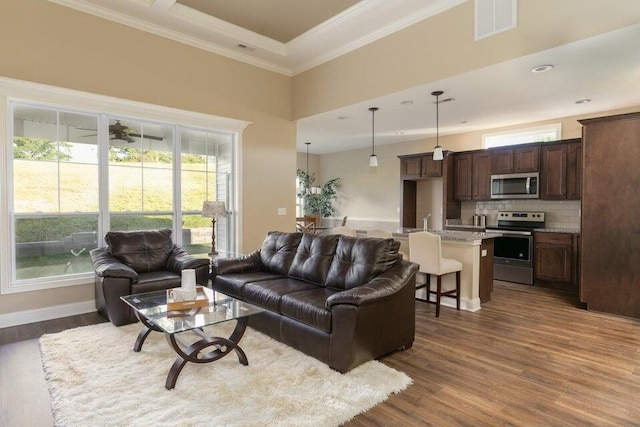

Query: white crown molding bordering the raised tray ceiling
[48,0,469,76]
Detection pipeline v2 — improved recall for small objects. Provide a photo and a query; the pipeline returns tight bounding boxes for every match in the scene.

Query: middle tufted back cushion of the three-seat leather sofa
[288,233,339,286]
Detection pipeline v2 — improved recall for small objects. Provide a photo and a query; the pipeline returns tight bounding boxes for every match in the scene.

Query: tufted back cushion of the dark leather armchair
[104,229,173,273]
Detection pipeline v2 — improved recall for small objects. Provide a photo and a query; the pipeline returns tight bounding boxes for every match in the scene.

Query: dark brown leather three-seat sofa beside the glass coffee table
[211,232,418,372]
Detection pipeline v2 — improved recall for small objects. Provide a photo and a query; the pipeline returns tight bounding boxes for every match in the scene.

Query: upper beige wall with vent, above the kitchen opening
[293,0,640,119]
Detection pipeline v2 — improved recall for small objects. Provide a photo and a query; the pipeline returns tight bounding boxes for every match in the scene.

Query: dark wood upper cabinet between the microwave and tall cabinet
[540,140,582,200]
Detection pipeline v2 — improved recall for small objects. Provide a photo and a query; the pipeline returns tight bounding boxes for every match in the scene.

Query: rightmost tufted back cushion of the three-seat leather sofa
[325,236,400,289]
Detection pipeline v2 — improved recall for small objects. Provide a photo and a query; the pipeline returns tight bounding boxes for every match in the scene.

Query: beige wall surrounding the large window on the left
[0,0,296,314]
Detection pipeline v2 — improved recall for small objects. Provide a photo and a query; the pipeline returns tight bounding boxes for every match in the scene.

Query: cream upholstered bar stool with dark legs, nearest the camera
[409,232,462,317]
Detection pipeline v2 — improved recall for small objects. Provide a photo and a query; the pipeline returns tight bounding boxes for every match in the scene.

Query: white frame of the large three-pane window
[0,78,250,294]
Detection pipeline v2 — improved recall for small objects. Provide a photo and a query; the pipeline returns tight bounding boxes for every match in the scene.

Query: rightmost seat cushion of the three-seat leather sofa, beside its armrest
[280,287,340,332]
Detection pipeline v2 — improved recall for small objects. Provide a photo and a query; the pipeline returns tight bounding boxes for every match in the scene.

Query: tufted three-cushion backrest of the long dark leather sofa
[260,232,400,289]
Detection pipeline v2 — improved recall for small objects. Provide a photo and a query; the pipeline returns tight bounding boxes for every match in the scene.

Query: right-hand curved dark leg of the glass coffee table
[165,317,249,390]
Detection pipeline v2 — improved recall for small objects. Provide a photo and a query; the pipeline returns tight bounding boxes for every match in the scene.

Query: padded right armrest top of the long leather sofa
[325,260,418,310]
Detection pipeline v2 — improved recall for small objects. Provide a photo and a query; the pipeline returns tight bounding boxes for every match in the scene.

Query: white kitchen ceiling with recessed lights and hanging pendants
[297,24,640,154]
